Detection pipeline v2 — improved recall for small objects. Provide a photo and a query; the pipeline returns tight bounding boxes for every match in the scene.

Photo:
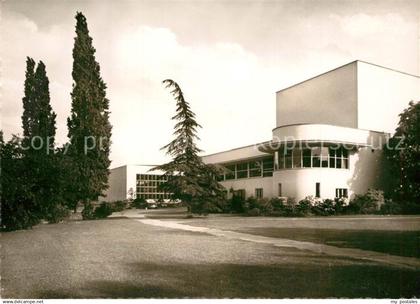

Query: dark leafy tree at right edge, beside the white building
[384,101,420,212]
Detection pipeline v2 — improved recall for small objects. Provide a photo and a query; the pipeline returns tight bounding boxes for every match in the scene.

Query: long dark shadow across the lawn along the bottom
[40,263,420,298]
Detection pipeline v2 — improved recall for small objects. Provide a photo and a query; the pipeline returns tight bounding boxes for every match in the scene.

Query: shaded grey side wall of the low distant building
[99,166,127,202]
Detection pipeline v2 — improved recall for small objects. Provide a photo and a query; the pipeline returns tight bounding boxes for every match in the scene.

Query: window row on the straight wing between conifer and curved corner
[218,156,274,181]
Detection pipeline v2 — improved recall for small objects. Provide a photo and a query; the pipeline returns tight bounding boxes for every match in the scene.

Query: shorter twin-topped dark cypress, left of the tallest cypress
[22,58,59,217]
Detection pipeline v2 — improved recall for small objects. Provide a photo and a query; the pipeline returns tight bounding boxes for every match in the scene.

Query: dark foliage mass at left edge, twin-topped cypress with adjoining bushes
[1,58,60,230]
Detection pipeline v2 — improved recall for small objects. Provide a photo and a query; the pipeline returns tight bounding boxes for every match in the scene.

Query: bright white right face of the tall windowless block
[357,61,420,134]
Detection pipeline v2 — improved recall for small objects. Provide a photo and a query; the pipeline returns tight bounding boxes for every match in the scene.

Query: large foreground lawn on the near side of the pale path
[1,217,420,298]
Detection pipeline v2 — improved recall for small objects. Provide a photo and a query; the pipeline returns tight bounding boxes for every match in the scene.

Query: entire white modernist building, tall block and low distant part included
[105,61,420,201]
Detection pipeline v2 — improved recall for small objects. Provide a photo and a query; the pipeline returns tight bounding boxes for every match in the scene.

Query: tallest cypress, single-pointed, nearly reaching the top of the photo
[67,12,111,208]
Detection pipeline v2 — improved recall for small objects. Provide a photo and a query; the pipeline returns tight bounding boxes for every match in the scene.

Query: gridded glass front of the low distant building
[136,174,171,200]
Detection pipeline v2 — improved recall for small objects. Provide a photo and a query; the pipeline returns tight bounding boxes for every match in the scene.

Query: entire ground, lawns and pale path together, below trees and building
[1,210,420,298]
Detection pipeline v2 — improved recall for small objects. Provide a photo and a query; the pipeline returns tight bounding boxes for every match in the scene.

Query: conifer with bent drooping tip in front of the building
[153,79,224,213]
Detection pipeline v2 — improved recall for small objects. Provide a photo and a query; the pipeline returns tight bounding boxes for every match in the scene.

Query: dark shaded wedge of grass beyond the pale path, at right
[237,227,420,258]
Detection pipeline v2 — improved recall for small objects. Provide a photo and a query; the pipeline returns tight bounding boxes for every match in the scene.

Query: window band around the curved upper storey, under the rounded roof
[279,147,349,169]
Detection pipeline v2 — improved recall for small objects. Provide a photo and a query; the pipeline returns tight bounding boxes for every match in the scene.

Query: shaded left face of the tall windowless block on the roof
[276,62,357,128]
